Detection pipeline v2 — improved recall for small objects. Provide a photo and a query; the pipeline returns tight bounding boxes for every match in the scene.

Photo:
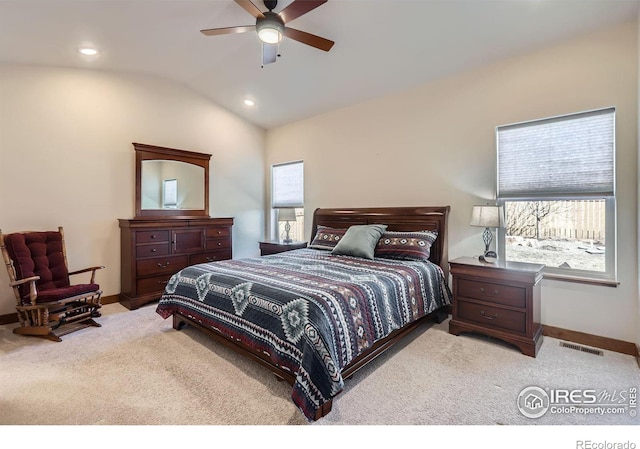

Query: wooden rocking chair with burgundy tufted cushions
[0,226,104,341]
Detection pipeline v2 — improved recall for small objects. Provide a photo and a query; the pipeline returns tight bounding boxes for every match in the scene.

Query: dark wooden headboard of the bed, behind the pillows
[309,206,450,279]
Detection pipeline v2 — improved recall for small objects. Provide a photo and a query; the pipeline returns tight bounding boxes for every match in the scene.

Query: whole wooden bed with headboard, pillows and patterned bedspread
[156,206,451,420]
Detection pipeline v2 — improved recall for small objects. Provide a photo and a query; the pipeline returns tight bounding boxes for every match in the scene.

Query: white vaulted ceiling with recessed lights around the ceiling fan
[0,0,640,129]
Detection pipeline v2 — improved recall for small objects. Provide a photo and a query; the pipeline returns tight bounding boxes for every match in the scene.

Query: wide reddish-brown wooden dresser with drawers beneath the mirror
[119,217,233,309]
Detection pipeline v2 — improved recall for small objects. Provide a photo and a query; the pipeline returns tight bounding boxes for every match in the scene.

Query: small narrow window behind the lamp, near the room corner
[271,161,304,241]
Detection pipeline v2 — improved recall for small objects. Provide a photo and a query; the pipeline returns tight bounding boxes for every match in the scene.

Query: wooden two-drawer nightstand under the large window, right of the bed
[449,257,544,357]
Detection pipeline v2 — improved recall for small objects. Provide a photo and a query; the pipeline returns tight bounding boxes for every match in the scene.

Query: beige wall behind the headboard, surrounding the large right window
[266,21,638,341]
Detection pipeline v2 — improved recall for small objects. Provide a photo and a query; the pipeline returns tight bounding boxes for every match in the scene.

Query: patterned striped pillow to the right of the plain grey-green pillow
[375,231,438,261]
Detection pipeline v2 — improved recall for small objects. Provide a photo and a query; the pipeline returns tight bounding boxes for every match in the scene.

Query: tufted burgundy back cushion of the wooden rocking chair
[4,231,71,302]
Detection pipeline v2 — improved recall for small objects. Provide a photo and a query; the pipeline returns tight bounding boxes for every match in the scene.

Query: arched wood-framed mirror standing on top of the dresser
[133,142,211,218]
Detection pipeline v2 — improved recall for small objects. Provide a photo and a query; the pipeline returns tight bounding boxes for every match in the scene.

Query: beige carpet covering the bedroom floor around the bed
[0,304,640,428]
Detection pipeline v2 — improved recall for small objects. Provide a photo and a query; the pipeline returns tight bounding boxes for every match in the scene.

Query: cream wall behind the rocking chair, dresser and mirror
[0,65,265,315]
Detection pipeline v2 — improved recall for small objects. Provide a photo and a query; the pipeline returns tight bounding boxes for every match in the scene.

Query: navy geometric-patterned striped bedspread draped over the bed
[156,249,451,419]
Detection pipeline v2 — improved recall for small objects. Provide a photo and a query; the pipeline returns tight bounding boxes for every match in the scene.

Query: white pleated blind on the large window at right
[496,108,615,198]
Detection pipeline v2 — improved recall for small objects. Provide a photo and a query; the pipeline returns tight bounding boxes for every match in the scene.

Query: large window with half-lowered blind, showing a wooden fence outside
[496,108,616,281]
